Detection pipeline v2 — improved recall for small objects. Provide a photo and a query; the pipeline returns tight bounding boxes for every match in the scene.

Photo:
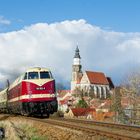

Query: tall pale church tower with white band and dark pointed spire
[71,46,83,91]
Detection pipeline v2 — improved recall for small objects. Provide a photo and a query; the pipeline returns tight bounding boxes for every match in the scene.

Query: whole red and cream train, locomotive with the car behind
[0,67,58,117]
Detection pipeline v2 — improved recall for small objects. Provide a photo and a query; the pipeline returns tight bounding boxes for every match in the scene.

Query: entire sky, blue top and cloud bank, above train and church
[0,0,140,87]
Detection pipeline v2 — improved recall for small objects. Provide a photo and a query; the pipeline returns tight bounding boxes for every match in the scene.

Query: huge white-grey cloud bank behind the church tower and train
[0,20,140,87]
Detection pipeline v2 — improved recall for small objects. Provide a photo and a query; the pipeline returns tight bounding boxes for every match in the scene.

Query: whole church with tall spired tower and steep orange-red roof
[71,46,114,99]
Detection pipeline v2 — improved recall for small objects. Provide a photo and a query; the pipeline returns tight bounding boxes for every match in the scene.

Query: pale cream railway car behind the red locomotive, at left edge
[0,88,8,113]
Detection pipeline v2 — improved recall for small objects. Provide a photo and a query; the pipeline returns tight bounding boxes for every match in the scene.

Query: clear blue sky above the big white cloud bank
[0,0,140,32]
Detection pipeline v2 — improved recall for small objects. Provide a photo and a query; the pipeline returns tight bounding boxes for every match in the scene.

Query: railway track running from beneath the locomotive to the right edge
[26,117,140,140]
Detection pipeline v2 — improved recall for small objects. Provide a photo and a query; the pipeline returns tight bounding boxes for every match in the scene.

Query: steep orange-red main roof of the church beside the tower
[86,71,109,85]
